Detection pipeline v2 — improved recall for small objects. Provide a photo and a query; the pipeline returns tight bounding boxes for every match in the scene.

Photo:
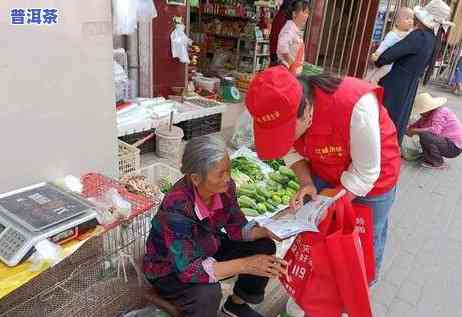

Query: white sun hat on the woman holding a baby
[414,0,453,33]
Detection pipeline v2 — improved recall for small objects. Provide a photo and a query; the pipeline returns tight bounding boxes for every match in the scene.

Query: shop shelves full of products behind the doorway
[191,0,277,75]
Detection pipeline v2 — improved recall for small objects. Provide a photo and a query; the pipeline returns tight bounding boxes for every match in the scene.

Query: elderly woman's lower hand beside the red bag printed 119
[242,254,287,278]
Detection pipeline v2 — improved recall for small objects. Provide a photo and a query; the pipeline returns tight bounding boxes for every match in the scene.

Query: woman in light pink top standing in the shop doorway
[277,0,310,75]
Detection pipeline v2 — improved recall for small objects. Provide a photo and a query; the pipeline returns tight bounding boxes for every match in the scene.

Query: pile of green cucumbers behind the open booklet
[231,157,300,217]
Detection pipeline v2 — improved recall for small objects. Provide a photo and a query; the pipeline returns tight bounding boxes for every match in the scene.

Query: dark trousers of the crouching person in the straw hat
[419,132,462,166]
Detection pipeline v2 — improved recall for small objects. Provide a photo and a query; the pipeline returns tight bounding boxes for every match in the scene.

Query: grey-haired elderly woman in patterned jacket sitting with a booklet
[144,136,286,317]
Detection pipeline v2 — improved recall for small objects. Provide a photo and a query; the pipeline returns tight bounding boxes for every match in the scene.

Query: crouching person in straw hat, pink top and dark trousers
[407,93,462,168]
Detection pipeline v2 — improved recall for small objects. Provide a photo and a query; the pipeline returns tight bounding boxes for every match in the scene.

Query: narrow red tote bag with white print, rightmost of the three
[353,202,375,284]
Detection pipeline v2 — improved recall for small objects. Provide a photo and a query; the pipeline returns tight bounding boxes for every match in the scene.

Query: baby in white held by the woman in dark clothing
[366,7,414,85]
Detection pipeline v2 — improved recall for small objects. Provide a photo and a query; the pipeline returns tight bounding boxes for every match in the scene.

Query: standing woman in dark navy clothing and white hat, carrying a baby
[375,0,450,144]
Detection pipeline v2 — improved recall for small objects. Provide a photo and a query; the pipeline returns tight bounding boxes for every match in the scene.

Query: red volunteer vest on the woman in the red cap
[295,77,401,196]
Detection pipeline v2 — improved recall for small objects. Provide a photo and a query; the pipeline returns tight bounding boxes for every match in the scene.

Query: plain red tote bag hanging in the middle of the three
[326,197,372,317]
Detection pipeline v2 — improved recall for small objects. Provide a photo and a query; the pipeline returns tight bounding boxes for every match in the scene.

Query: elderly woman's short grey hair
[181,135,228,178]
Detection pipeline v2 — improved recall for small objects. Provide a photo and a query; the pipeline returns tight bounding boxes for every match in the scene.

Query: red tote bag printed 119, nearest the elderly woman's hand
[281,204,343,317]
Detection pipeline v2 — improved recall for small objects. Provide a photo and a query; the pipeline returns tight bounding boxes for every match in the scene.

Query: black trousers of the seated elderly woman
[153,238,276,317]
